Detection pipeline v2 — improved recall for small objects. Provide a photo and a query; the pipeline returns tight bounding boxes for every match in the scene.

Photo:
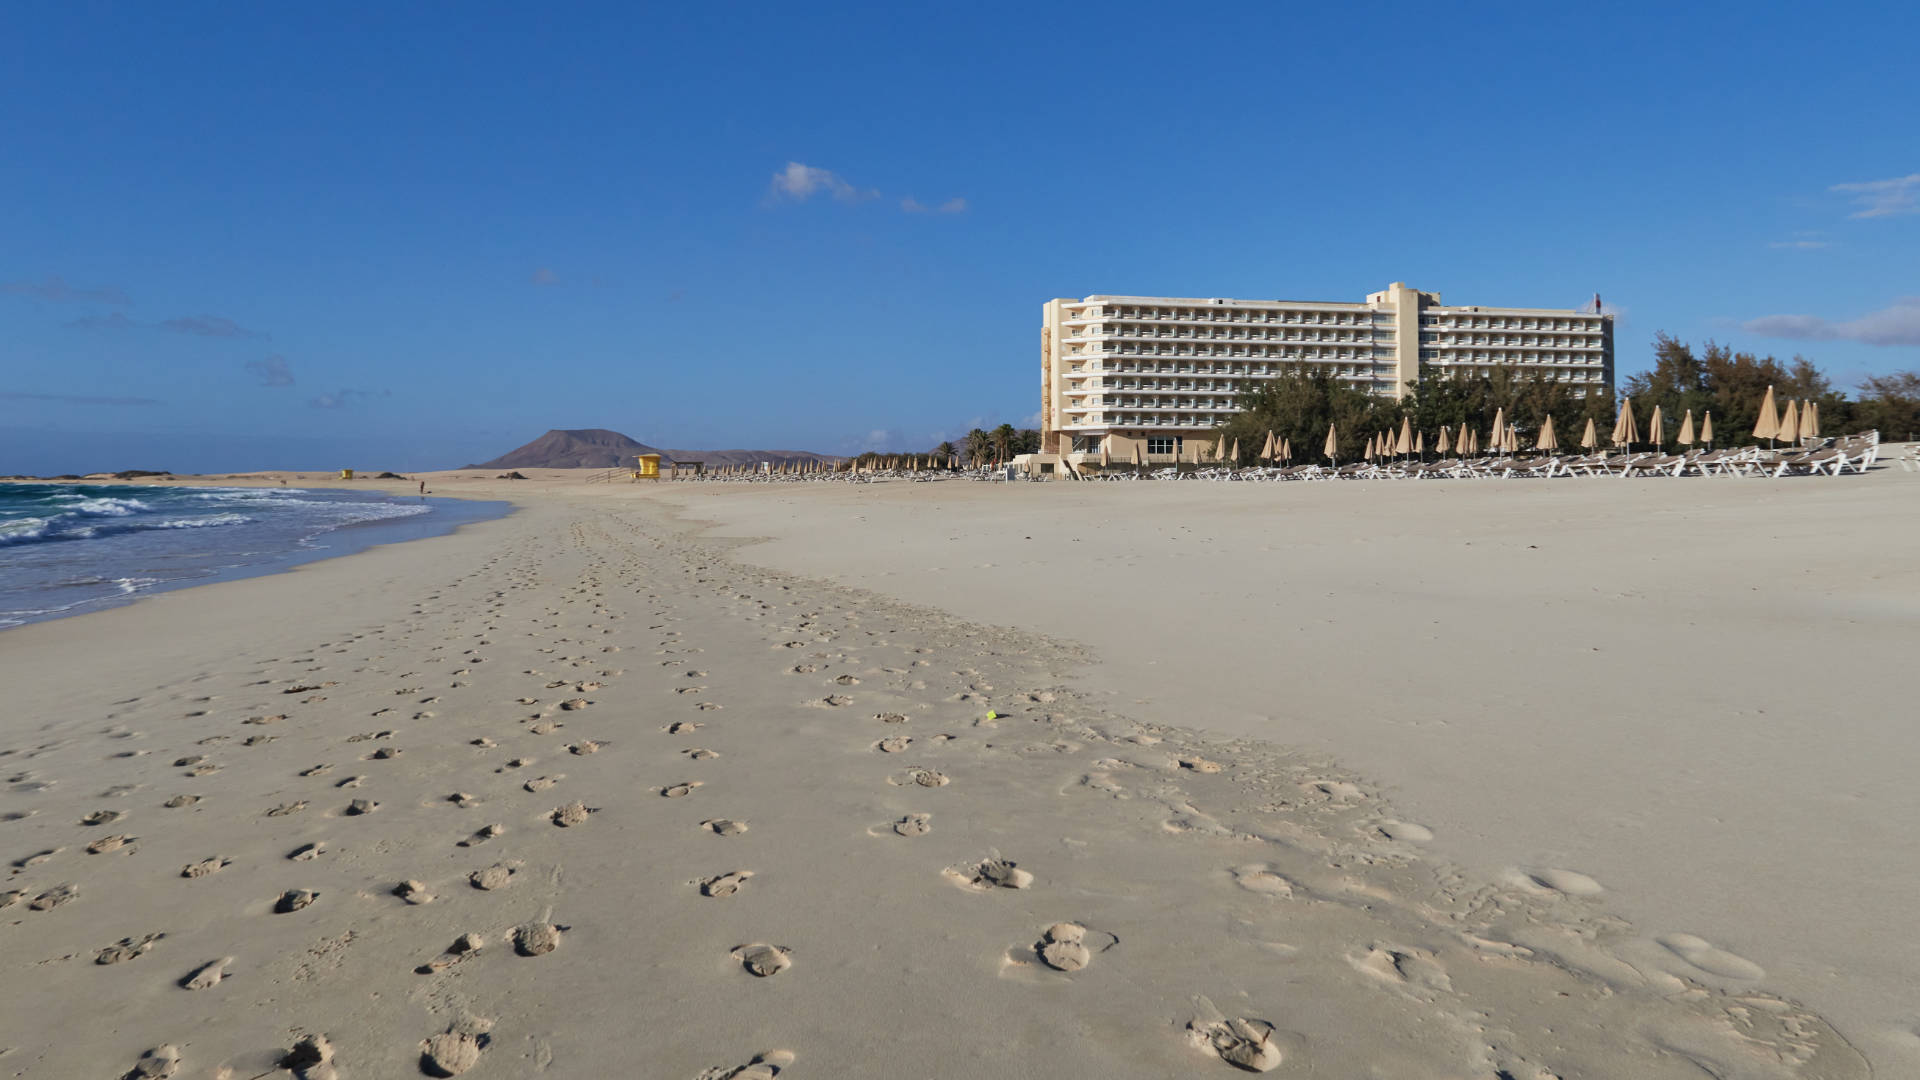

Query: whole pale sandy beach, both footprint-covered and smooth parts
[0,469,1920,1080]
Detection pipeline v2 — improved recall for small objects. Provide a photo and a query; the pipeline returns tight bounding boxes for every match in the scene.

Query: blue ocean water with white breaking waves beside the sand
[0,484,509,630]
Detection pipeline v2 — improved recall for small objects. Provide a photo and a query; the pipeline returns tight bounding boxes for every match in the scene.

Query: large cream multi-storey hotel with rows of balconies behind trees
[1041,281,1613,459]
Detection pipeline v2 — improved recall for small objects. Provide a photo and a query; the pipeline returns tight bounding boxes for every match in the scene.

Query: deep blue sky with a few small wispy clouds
[0,2,1920,473]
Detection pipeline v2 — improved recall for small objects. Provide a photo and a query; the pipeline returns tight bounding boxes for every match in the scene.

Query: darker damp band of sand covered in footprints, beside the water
[0,474,1889,1080]
